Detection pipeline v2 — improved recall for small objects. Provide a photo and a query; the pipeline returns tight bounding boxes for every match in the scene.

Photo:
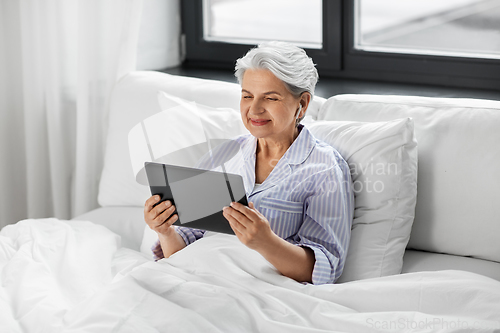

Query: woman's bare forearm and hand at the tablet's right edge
[223,202,315,282]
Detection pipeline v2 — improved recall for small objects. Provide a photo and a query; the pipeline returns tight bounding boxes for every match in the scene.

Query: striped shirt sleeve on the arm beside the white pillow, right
[288,166,354,284]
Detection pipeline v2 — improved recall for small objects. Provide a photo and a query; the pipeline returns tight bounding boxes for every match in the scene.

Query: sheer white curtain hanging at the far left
[0,0,143,227]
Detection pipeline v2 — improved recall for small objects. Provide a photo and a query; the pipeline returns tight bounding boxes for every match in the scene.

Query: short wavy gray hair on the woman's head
[234,42,318,122]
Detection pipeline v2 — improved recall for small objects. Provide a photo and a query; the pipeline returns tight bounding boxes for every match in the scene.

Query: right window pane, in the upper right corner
[355,0,500,59]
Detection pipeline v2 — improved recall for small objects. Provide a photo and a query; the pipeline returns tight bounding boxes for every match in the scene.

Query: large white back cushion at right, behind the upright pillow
[318,95,500,262]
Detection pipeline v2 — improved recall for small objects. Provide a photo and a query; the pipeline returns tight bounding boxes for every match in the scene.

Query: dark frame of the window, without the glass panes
[181,0,500,91]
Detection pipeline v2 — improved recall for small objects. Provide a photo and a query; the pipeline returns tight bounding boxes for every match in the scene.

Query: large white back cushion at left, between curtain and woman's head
[98,71,241,207]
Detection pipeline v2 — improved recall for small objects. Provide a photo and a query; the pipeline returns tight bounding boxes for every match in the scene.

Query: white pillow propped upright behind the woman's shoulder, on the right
[305,118,417,282]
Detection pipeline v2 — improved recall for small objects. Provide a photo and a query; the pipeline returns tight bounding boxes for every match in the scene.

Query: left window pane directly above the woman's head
[203,0,323,49]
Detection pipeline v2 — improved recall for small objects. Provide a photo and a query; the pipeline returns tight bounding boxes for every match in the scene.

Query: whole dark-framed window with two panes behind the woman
[181,0,500,90]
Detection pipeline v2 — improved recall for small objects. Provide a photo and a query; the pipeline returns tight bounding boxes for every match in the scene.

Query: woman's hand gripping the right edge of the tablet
[222,202,276,251]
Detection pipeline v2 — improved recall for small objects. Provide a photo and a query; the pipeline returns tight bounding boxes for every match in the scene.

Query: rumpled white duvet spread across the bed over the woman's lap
[0,219,500,333]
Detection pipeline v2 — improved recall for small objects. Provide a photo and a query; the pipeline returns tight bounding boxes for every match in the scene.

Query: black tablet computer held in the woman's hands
[145,162,248,235]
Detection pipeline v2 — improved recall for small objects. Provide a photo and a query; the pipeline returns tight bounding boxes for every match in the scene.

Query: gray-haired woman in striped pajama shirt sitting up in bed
[144,42,353,284]
